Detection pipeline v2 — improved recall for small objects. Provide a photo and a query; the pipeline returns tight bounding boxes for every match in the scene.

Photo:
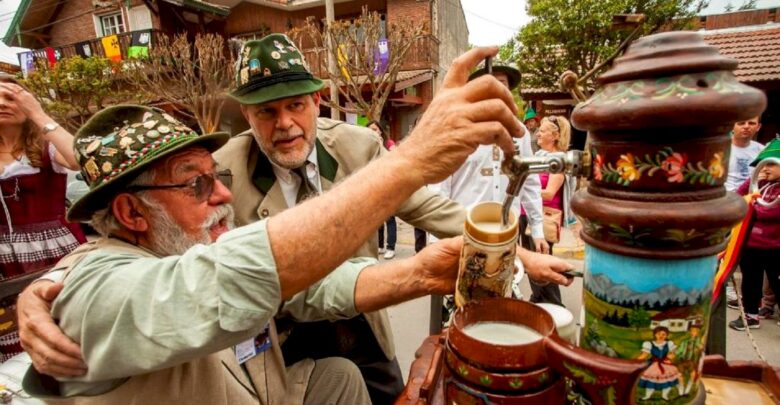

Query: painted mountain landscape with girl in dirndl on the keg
[580,246,717,404]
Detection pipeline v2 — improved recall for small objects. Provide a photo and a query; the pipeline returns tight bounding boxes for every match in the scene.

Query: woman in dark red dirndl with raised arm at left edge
[0,76,85,362]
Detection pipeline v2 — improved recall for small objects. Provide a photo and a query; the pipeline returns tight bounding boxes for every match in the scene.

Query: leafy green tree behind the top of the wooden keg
[508,0,707,88]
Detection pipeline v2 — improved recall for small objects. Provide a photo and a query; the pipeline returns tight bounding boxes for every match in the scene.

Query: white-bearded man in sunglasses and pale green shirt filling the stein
[20,48,532,404]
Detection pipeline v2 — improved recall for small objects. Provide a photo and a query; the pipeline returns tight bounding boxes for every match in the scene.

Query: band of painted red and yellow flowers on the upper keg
[593,146,726,186]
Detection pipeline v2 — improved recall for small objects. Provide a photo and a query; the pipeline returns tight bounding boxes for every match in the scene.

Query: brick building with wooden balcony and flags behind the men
[5,0,468,139]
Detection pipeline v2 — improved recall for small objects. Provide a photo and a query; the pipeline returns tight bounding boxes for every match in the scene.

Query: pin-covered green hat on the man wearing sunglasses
[68,105,230,221]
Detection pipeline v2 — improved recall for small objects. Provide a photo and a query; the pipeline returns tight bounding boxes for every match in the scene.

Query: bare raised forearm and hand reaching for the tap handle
[268,48,521,298]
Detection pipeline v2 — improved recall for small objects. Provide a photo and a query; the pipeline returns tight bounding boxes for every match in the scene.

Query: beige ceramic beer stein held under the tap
[455,202,518,307]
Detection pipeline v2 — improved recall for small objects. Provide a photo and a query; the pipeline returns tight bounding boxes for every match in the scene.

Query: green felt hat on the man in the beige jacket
[230,34,324,104]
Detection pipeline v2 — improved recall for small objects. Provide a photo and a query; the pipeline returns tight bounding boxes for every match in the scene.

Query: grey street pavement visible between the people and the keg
[383,220,780,378]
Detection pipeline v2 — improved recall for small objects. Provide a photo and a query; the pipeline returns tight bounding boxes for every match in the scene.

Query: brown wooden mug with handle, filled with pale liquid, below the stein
[444,298,647,404]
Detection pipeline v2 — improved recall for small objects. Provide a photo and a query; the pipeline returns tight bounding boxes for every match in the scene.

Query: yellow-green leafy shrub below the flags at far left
[22,56,135,131]
